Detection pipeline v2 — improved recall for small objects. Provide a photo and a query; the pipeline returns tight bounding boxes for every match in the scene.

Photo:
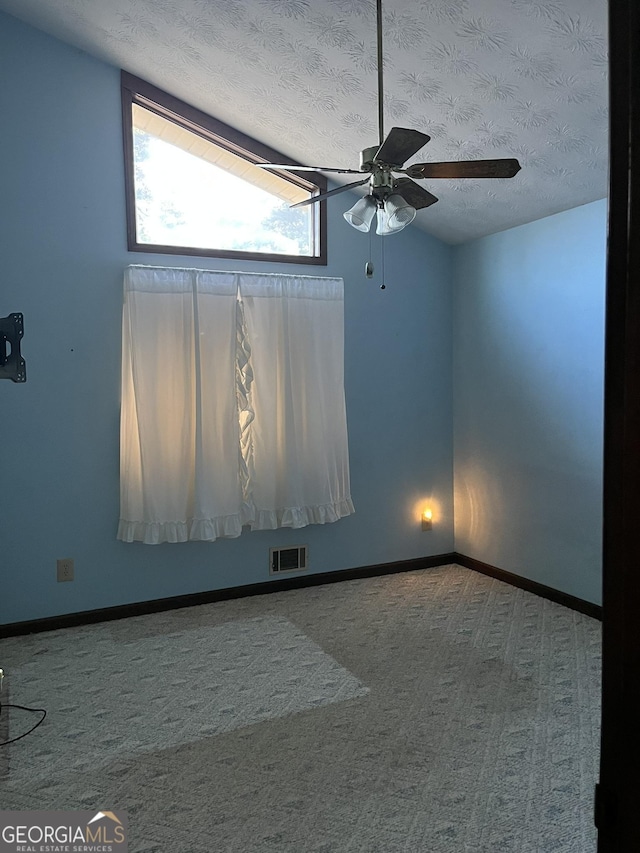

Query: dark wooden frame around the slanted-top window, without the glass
[120,71,327,266]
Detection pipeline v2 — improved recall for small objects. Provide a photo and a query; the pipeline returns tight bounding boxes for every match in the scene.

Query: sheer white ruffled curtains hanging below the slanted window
[118,266,354,543]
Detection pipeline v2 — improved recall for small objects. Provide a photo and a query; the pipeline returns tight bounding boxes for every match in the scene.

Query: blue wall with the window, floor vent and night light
[0,14,453,623]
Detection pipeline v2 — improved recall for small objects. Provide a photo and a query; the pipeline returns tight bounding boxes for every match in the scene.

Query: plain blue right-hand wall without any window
[454,201,607,603]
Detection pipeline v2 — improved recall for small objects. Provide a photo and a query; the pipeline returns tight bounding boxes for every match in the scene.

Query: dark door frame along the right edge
[596,0,640,853]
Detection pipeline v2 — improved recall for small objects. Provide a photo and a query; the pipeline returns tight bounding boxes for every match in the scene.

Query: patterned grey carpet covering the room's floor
[0,566,601,853]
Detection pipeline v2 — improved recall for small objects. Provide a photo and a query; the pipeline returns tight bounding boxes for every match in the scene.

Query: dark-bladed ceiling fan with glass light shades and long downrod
[256,0,520,235]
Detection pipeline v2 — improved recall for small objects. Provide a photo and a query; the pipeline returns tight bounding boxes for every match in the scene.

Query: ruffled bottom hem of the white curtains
[117,498,355,545]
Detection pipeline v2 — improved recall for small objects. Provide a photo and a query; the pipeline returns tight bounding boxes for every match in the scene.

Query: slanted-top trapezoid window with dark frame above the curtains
[122,71,327,264]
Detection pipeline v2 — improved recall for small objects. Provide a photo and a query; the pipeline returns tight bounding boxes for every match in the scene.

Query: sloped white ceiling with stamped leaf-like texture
[0,0,608,243]
